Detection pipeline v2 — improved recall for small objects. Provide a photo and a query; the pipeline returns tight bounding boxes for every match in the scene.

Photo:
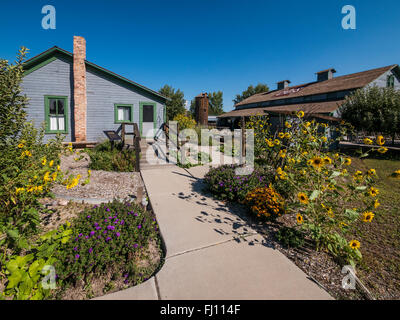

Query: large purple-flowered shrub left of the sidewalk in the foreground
[56,201,158,285]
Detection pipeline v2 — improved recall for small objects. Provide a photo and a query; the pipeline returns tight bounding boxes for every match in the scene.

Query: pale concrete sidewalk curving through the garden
[98,166,332,299]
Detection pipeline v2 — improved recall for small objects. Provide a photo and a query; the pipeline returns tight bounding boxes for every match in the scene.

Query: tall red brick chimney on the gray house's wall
[73,36,87,142]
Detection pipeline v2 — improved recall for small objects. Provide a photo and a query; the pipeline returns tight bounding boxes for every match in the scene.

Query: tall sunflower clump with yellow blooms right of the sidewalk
[265,111,387,265]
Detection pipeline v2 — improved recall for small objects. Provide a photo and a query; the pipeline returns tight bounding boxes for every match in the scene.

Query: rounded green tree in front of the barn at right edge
[339,86,400,141]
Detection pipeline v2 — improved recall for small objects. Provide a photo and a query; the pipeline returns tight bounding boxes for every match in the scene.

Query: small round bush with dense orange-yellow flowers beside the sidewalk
[244,185,284,220]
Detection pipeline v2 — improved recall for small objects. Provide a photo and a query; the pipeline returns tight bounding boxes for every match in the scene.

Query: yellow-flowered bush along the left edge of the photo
[0,123,85,254]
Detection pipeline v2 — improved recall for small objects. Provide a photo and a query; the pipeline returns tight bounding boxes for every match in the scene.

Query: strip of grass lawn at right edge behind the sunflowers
[344,151,400,299]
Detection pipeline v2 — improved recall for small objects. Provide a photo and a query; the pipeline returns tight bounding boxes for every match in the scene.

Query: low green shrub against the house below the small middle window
[86,141,136,172]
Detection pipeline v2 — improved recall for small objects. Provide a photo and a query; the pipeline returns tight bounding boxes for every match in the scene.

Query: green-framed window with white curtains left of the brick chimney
[44,96,68,133]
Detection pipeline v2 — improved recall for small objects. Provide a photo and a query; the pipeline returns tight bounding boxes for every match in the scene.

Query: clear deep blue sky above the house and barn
[0,0,400,111]
